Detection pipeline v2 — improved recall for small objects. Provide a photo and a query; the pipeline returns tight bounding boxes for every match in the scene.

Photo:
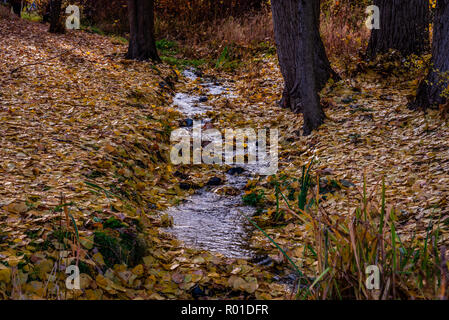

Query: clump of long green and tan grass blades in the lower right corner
[248,165,448,300]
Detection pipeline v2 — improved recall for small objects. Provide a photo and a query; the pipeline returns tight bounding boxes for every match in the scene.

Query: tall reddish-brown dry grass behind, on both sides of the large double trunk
[156,1,370,69]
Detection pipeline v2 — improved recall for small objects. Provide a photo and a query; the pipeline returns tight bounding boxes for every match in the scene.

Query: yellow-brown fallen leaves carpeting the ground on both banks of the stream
[0,16,449,299]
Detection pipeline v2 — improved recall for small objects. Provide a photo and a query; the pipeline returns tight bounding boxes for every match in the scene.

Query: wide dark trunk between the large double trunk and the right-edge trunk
[366,0,430,58]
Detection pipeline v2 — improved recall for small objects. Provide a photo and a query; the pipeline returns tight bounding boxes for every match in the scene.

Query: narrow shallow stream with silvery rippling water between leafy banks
[165,70,257,259]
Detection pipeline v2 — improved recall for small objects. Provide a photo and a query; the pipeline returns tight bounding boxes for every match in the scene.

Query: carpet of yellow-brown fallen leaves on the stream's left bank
[0,20,285,299]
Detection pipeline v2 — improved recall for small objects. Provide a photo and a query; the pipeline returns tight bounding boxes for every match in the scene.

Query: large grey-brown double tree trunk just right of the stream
[271,0,328,135]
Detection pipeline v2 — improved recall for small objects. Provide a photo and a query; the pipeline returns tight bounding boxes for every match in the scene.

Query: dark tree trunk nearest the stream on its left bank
[126,0,160,62]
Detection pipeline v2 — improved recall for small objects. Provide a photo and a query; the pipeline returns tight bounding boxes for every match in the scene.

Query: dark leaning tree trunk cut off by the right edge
[410,0,449,109]
